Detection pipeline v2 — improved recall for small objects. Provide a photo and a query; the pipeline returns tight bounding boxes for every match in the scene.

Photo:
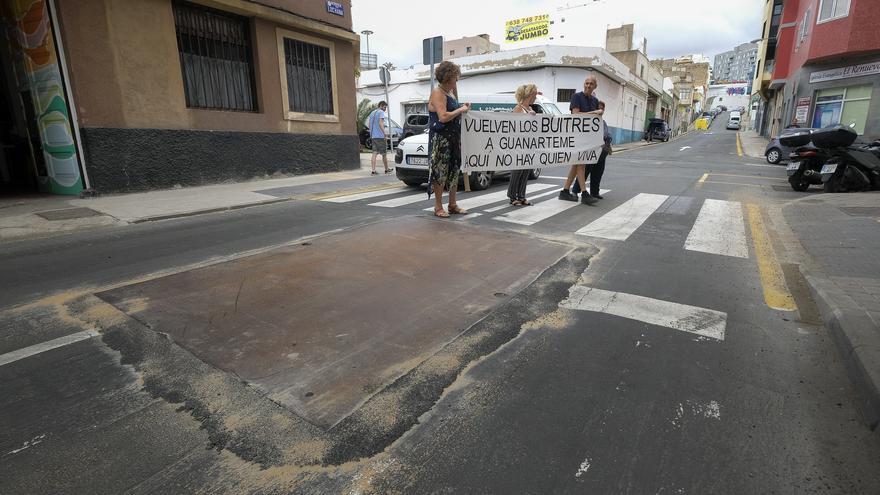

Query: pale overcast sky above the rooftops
[351,0,764,68]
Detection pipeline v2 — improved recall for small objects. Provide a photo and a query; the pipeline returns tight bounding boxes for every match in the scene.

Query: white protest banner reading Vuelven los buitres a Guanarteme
[461,112,604,172]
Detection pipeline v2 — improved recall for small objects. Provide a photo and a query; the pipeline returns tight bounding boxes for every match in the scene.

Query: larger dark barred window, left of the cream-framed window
[173,0,257,112]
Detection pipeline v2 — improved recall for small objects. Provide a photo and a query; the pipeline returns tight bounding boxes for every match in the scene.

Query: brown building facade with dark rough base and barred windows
[0,0,359,194]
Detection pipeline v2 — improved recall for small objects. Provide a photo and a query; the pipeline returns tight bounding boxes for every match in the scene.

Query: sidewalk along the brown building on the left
[0,153,400,242]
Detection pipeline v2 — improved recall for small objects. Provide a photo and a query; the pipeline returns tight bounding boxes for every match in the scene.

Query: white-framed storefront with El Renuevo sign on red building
[786,56,880,139]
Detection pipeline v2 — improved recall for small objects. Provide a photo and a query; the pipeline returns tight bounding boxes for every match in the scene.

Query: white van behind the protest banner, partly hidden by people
[394,93,563,191]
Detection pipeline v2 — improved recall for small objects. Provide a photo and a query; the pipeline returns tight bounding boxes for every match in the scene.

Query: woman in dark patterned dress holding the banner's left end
[428,60,470,218]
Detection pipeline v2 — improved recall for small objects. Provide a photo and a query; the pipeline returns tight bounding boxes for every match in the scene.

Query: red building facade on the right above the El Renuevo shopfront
[769,0,880,139]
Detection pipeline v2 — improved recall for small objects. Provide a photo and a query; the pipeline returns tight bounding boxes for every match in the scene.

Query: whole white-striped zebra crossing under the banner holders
[321,182,749,258]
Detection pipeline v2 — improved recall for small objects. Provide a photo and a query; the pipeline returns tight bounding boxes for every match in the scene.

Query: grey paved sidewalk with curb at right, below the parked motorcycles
[782,192,880,428]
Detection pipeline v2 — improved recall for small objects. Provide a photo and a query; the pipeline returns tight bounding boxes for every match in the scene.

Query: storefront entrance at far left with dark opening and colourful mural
[0,0,88,195]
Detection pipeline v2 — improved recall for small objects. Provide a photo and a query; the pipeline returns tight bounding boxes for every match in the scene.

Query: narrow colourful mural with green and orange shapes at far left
[0,0,83,194]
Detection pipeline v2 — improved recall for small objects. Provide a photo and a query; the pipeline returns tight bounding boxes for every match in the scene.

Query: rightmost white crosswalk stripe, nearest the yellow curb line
[684,199,749,258]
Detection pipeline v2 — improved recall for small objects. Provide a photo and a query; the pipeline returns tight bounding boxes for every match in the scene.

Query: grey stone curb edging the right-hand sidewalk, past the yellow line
[800,266,880,431]
